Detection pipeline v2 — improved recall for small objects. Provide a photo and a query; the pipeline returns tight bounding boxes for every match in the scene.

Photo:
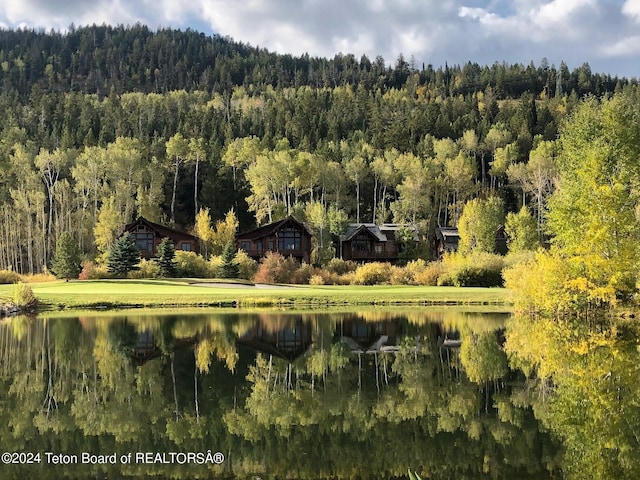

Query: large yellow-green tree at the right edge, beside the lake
[548,91,640,295]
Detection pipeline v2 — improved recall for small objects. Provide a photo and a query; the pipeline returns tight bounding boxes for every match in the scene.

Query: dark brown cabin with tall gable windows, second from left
[236,216,311,263]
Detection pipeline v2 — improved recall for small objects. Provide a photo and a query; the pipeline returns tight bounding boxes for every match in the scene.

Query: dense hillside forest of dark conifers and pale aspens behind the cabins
[0,25,637,273]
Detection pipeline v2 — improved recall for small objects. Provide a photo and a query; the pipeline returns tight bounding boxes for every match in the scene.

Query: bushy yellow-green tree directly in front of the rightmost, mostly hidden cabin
[458,197,504,255]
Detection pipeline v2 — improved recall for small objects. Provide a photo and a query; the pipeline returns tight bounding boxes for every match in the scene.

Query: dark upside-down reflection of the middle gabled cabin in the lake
[236,317,313,362]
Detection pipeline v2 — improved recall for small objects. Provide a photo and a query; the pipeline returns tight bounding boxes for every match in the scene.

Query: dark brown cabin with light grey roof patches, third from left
[338,223,418,263]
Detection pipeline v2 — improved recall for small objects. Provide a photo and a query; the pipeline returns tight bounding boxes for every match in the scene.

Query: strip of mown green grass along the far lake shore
[0,279,510,308]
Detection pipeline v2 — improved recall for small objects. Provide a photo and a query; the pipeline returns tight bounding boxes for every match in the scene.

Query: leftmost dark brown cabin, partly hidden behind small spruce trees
[122,217,199,258]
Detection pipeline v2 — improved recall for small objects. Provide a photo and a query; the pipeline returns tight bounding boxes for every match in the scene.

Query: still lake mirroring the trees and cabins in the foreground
[0,307,640,479]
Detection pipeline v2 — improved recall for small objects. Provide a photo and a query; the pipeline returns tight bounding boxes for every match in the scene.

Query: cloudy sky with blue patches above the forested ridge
[0,0,640,78]
